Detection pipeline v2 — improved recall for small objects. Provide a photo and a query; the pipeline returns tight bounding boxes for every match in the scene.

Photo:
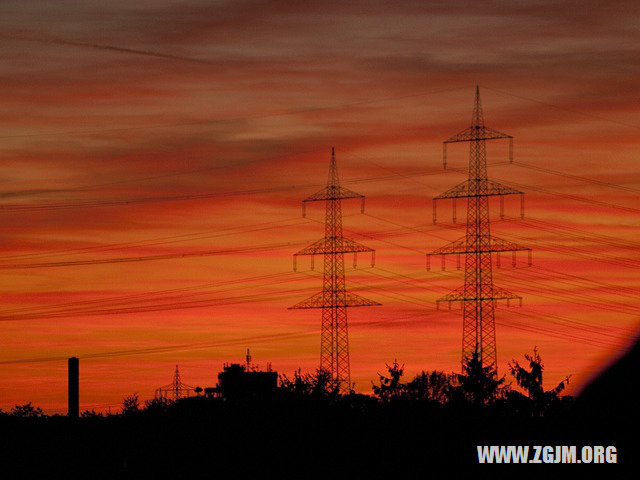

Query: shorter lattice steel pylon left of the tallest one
[290,147,380,393]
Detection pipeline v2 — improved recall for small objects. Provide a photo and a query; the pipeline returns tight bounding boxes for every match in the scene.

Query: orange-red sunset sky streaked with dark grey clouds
[0,0,640,413]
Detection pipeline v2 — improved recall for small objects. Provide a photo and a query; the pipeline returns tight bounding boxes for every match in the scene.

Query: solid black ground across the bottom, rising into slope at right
[0,338,640,480]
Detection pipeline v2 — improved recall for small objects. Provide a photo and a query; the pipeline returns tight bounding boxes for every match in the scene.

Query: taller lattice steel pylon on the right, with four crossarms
[427,87,531,372]
